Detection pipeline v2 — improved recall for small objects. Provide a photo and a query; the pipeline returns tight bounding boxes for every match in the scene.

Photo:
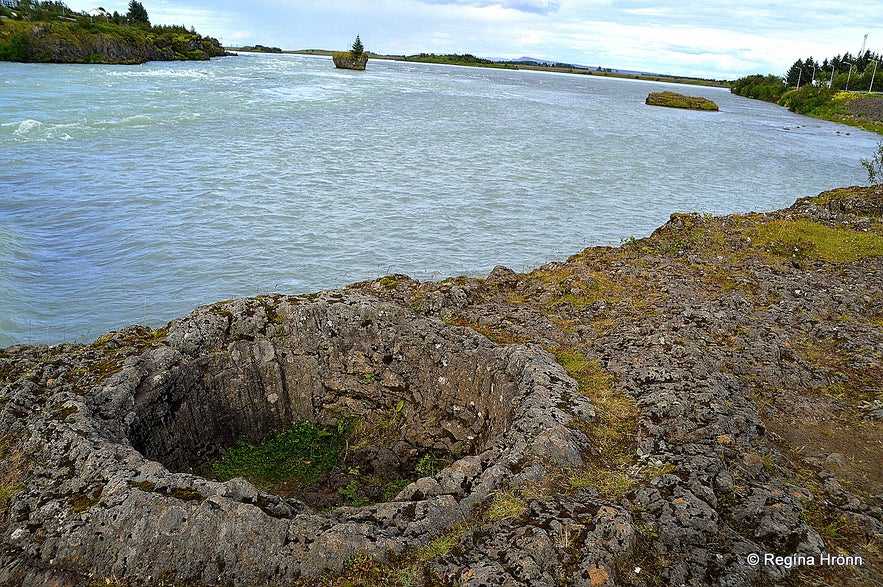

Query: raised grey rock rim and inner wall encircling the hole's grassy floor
[0,292,593,584]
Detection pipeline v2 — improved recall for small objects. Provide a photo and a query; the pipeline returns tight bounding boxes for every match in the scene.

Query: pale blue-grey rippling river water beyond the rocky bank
[0,54,877,347]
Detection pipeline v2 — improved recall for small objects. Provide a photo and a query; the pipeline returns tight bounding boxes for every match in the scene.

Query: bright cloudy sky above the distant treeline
[66,0,883,79]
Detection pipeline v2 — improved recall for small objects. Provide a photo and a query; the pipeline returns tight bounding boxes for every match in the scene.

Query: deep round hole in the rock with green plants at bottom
[128,301,517,509]
